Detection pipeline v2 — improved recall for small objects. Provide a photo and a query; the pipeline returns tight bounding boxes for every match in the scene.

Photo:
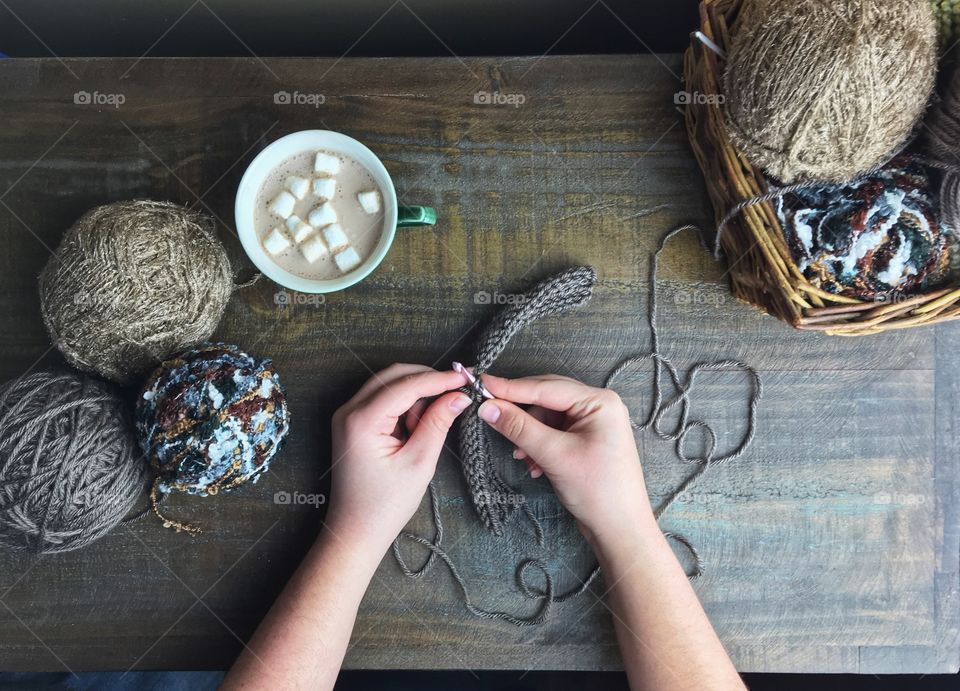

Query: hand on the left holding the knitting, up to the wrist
[326,364,470,554]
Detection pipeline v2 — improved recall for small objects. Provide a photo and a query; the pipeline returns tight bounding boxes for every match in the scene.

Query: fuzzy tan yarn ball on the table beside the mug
[40,201,232,383]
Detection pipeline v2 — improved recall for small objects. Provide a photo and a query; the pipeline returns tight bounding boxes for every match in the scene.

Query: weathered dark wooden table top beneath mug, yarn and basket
[0,55,960,673]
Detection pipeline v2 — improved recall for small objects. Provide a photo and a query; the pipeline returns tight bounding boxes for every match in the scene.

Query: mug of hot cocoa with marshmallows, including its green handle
[235,130,436,293]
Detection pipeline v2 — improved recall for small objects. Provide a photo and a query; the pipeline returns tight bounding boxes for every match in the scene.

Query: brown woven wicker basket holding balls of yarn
[683,0,960,336]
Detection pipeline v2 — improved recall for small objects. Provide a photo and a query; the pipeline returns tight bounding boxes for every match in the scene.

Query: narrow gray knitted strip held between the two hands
[460,266,597,542]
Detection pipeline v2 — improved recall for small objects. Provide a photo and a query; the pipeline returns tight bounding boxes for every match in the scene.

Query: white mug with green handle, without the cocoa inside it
[234,130,437,293]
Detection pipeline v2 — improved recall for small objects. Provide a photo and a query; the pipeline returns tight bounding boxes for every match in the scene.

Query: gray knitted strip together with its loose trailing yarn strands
[393,225,763,626]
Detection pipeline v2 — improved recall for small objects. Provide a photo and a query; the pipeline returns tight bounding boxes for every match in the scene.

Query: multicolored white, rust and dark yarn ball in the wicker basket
[777,156,950,300]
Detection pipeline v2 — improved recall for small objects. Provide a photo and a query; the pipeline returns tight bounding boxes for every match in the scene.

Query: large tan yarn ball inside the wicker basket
[724,0,937,183]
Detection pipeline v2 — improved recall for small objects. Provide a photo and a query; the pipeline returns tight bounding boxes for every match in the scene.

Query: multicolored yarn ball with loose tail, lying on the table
[136,343,290,532]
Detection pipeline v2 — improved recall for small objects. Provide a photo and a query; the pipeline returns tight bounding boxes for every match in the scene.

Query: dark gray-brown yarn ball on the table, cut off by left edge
[0,372,147,552]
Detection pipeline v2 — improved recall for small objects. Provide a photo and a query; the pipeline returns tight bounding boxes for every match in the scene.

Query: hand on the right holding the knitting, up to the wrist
[479,374,653,542]
